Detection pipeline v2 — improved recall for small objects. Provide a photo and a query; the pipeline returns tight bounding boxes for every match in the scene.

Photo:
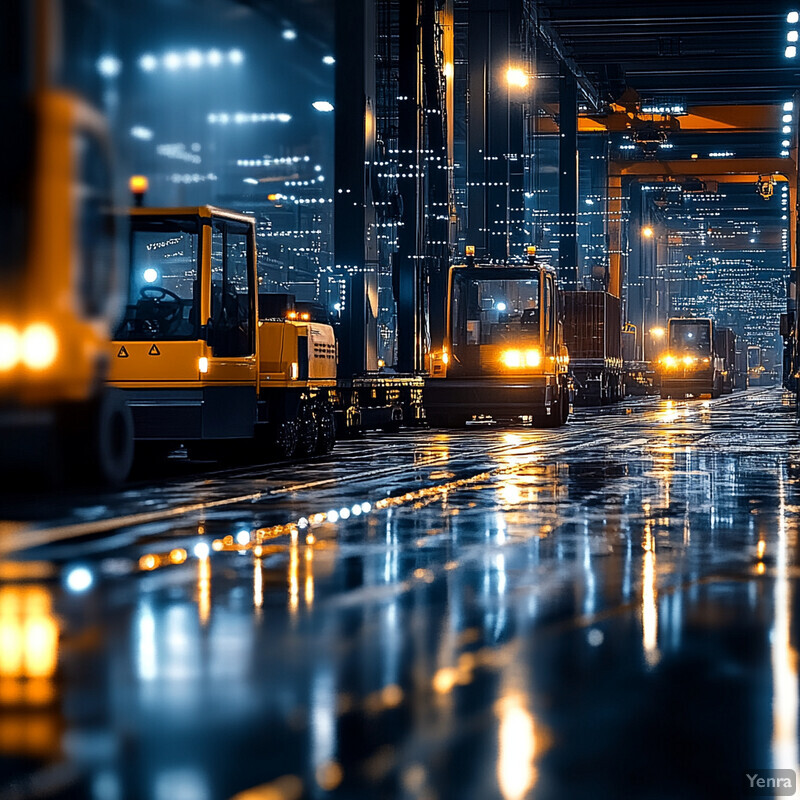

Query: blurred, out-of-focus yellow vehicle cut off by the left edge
[0,0,133,484]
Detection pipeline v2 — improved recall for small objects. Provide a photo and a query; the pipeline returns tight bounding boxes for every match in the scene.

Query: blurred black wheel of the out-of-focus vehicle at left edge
[64,389,134,488]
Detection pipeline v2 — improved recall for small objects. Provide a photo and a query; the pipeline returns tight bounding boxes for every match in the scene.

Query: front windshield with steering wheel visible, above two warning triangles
[115,217,200,341]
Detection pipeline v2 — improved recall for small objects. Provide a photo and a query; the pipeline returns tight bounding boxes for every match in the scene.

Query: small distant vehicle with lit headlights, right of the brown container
[658,318,723,398]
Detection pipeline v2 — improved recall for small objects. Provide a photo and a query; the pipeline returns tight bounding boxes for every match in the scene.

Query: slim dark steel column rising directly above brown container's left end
[558,65,580,290]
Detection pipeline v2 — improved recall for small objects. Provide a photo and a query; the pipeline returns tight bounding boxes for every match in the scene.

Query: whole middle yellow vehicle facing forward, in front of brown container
[424,257,571,427]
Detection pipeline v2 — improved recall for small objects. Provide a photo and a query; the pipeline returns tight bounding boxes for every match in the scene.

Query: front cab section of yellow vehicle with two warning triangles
[110,206,258,440]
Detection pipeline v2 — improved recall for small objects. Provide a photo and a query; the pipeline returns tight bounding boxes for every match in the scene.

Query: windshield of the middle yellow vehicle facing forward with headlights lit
[452,270,539,349]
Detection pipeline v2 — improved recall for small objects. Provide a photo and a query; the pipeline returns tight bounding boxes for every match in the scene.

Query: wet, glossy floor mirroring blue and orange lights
[0,391,800,800]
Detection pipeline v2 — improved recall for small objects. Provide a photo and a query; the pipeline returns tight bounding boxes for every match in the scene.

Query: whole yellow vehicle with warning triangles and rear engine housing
[110,206,337,458]
